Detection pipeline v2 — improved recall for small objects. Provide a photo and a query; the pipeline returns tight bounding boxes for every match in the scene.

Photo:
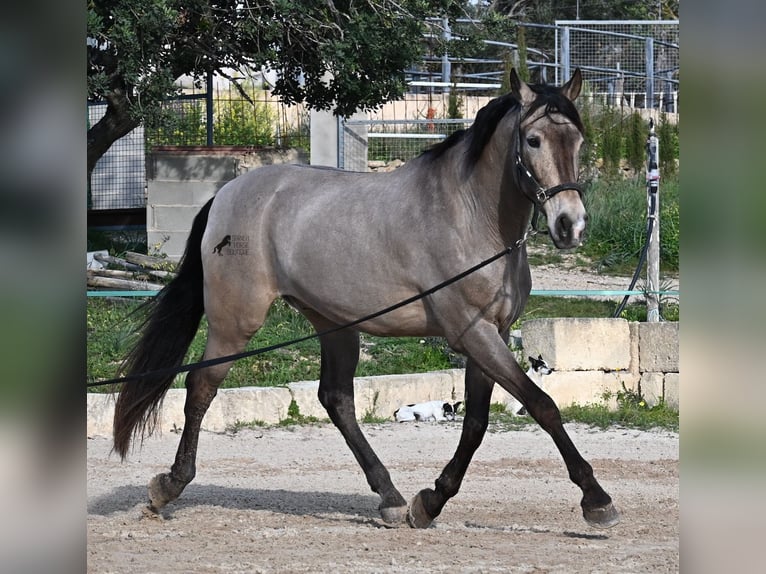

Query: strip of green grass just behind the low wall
[87,296,678,391]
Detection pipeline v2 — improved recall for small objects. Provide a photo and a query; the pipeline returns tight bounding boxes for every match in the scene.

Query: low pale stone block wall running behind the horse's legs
[87,319,679,436]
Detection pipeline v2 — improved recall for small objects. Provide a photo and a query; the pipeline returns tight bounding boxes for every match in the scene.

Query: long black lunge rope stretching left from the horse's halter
[86,231,534,388]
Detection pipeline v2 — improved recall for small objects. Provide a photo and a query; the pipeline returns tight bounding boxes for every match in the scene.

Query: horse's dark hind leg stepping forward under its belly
[304,310,407,524]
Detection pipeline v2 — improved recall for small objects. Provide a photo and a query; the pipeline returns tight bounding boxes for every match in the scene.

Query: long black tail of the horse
[114,199,213,459]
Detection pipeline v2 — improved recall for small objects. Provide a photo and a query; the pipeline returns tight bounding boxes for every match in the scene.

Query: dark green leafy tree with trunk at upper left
[87,0,465,180]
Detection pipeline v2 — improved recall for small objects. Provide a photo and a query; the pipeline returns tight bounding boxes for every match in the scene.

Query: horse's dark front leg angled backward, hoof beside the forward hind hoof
[407,359,494,528]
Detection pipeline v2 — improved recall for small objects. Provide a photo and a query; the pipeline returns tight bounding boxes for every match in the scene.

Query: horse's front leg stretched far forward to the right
[428,321,620,528]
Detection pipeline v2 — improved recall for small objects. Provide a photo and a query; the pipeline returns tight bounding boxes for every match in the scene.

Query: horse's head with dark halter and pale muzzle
[511,68,588,249]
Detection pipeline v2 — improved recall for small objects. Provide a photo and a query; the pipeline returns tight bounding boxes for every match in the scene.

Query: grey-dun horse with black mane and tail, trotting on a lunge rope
[113,69,620,528]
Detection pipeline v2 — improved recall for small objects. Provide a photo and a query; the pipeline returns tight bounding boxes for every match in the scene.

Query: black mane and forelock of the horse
[421,84,584,169]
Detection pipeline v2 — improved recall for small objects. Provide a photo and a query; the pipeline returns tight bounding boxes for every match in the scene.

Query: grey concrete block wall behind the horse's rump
[146,147,307,259]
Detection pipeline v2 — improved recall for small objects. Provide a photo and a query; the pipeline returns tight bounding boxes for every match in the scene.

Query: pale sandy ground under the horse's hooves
[87,422,679,574]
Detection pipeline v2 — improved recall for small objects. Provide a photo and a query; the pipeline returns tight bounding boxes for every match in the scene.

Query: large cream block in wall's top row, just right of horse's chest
[521,318,630,371]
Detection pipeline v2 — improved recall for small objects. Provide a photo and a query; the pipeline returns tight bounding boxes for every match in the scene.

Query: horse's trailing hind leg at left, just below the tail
[149,306,268,511]
